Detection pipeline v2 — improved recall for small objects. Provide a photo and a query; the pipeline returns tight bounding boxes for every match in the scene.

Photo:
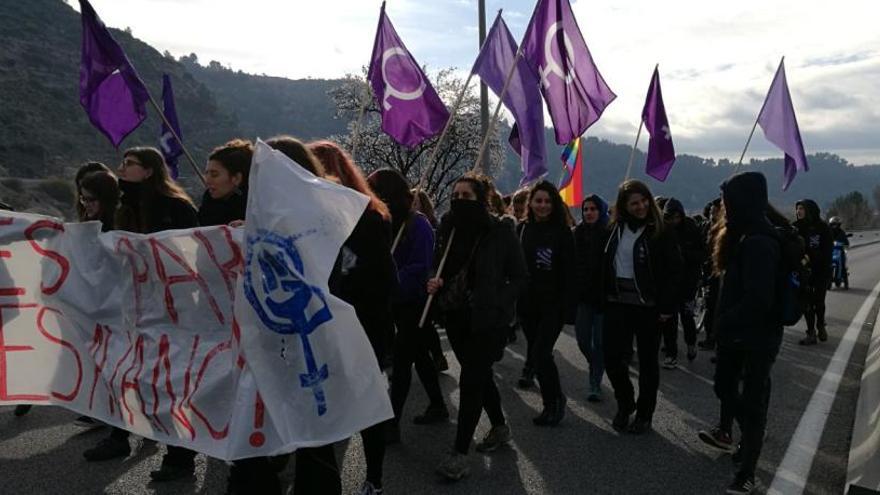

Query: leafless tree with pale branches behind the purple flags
[330,69,503,207]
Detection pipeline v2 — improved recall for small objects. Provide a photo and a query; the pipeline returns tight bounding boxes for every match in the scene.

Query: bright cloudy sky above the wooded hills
[79,0,880,165]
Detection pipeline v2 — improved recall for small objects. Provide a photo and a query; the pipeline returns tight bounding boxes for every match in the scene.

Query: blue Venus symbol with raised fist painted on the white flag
[244,230,333,416]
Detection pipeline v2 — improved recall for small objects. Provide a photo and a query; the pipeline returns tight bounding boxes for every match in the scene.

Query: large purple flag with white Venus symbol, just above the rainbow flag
[522,0,617,144]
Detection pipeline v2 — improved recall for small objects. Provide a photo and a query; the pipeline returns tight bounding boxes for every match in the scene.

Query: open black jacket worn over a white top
[602,223,682,314]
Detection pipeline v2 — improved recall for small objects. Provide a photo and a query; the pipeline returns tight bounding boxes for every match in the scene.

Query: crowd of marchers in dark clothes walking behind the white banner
[3,136,846,495]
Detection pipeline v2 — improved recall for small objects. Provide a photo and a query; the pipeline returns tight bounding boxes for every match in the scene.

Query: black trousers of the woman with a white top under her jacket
[604,303,660,419]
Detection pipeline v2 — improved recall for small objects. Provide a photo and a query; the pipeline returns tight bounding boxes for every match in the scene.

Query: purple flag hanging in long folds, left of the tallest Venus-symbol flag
[471,13,547,185]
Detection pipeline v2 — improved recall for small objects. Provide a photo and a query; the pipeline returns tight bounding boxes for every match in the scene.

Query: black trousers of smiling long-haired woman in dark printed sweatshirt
[522,300,564,407]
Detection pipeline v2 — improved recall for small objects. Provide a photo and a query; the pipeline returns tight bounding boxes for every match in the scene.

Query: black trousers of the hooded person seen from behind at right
[715,347,776,477]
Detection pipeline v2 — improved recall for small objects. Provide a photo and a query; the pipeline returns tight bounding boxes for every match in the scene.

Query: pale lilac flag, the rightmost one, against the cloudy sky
[758,58,810,191]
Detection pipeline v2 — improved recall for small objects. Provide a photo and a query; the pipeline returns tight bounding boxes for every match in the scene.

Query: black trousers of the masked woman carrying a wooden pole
[446,311,506,454]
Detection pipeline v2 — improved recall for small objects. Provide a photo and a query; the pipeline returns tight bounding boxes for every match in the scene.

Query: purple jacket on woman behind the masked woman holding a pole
[393,212,434,304]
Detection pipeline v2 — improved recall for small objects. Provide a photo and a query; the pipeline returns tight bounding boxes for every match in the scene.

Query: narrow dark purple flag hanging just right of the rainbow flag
[642,67,675,182]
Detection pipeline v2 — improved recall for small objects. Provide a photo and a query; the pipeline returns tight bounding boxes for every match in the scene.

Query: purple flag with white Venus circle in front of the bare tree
[367,2,449,148]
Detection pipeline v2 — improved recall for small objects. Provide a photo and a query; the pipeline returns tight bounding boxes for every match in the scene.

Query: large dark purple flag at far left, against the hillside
[79,0,150,148]
